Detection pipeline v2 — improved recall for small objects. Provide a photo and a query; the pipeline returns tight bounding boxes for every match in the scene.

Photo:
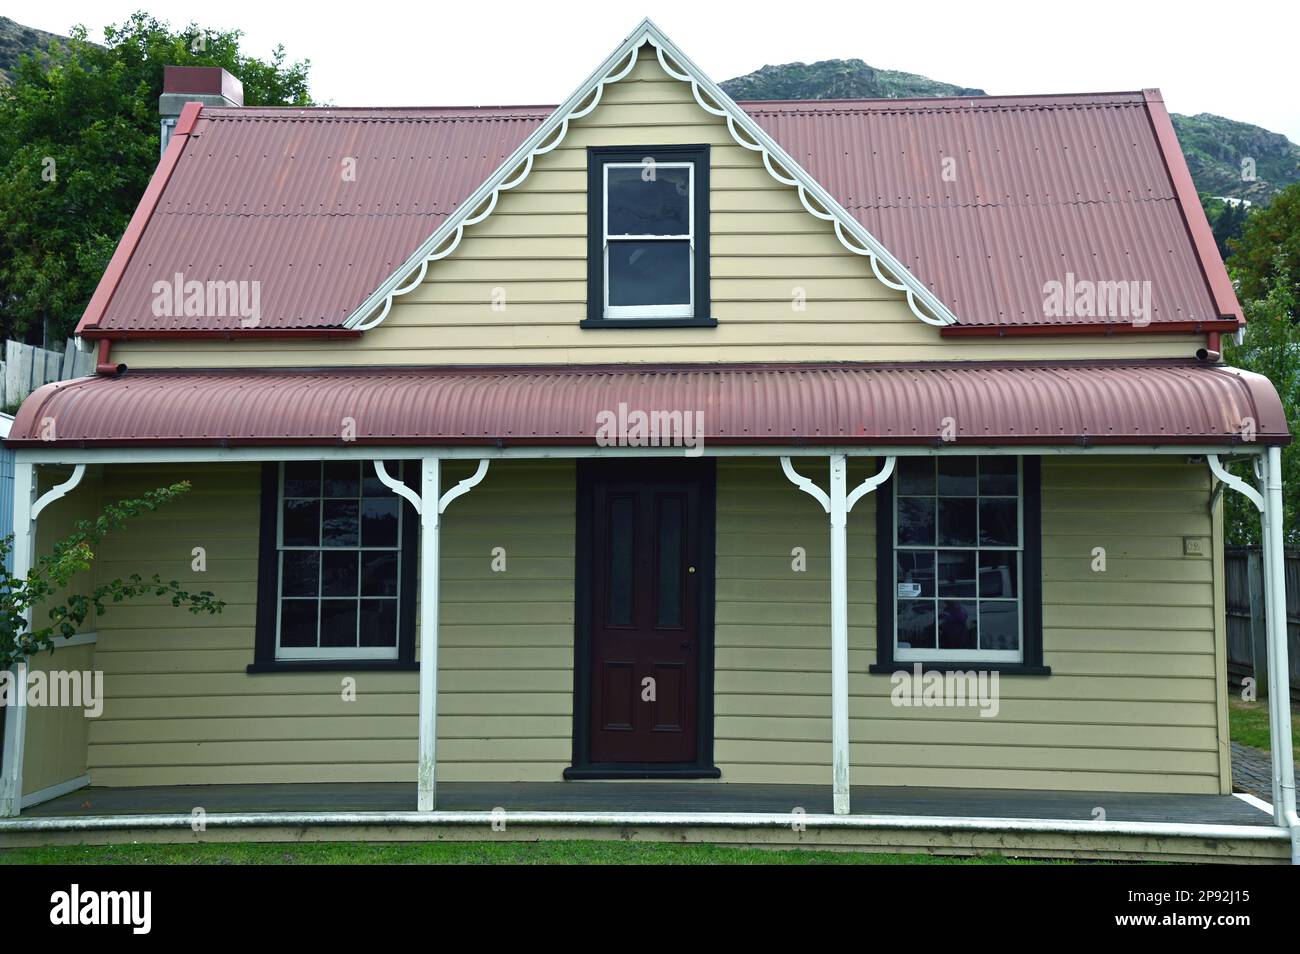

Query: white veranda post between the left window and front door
[374,458,488,811]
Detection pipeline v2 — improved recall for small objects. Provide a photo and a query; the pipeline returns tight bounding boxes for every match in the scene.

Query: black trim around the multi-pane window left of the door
[247,460,420,675]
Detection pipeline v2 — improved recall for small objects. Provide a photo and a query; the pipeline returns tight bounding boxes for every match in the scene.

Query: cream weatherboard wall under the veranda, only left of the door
[81,461,575,785]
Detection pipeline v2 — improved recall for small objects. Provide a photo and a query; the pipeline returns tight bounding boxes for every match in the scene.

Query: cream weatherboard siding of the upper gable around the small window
[113,52,1204,368]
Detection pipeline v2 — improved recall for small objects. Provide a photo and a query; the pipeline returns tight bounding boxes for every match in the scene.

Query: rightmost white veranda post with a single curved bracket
[1209,447,1300,864]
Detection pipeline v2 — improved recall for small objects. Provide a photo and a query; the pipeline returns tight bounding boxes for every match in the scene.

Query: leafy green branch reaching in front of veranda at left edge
[0,481,225,671]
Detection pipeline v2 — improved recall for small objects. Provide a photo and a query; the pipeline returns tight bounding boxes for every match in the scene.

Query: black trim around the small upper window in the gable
[579,143,718,329]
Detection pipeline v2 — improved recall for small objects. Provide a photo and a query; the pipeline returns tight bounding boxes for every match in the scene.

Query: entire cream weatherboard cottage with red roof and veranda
[0,21,1300,859]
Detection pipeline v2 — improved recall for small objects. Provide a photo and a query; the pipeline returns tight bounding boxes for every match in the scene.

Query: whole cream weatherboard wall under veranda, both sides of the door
[87,456,1227,807]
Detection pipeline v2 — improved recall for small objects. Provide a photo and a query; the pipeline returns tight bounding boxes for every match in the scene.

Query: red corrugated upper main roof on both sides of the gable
[79,94,1239,337]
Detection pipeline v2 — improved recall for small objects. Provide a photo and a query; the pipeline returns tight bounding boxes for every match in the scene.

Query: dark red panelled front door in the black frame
[588,461,712,764]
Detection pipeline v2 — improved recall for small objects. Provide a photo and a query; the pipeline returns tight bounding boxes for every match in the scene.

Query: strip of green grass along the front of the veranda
[0,841,1052,864]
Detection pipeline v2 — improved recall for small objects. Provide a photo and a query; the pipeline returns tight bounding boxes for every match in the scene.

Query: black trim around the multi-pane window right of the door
[867,456,1052,676]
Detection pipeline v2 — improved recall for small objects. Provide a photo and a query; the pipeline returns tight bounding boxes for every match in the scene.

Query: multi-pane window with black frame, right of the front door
[871,455,1049,675]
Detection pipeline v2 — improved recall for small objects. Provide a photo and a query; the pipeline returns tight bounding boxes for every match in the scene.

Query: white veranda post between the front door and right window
[781,454,894,815]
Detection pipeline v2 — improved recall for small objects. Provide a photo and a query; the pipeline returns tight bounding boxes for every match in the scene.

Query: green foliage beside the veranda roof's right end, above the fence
[1225,257,1300,546]
